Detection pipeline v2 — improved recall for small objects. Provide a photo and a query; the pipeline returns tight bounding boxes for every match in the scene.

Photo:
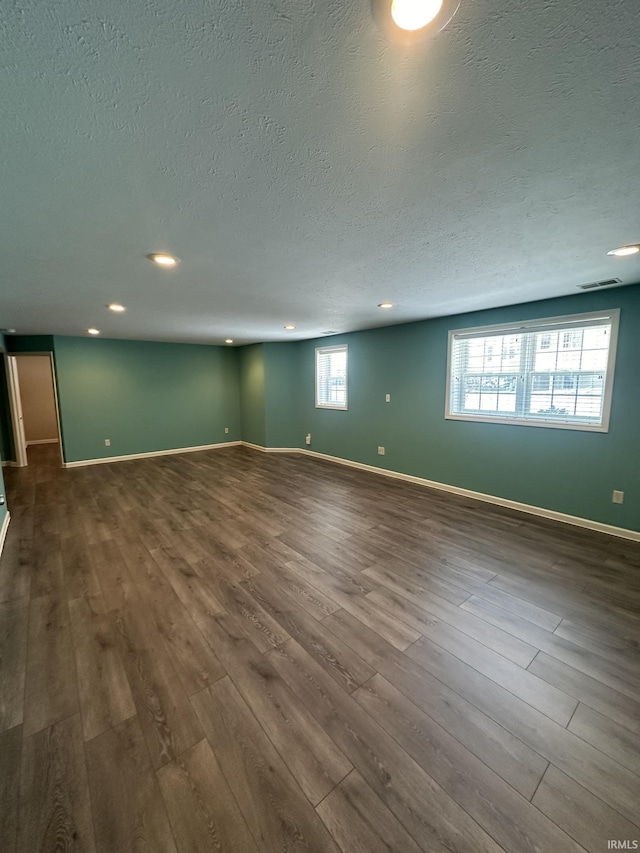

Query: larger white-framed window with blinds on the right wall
[445,310,620,432]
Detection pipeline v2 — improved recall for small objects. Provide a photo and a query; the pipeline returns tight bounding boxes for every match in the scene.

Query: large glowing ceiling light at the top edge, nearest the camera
[371,0,460,43]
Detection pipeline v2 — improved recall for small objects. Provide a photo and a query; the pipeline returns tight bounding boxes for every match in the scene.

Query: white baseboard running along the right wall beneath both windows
[242,441,640,542]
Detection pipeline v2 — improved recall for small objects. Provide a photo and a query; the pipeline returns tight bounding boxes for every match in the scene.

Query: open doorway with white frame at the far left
[5,353,63,468]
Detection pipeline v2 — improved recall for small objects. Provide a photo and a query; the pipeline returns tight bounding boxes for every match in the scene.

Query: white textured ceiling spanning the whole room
[0,0,640,343]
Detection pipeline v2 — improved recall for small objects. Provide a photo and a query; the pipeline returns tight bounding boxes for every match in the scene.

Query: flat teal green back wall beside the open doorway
[54,336,240,462]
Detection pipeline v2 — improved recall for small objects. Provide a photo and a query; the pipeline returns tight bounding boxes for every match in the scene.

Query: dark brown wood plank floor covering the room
[0,446,640,853]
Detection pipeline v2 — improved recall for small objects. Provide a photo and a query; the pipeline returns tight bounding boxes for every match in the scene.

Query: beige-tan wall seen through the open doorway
[16,355,58,443]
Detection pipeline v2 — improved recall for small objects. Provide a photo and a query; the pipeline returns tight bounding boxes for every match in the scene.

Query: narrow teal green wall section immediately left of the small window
[264,343,300,447]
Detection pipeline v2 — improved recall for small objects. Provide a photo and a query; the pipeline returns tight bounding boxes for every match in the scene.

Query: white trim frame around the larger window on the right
[444,308,620,432]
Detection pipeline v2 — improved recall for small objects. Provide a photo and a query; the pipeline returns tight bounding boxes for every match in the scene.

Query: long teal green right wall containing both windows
[296,286,640,530]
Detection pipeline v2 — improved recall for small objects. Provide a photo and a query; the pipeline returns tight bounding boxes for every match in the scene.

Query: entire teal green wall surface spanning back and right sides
[5,286,640,530]
